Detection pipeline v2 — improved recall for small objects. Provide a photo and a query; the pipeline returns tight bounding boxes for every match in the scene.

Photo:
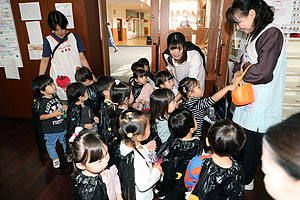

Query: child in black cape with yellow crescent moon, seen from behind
[158,108,203,200]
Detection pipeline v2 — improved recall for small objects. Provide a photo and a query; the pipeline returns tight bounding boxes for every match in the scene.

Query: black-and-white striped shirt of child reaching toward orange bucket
[183,97,215,137]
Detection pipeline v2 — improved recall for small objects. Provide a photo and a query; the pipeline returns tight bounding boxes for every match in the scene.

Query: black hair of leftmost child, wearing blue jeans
[31,75,53,98]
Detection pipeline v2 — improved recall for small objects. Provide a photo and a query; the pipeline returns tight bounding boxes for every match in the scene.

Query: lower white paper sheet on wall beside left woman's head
[26,21,43,44]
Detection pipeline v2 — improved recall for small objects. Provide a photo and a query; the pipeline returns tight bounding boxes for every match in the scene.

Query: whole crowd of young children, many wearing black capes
[32,58,246,200]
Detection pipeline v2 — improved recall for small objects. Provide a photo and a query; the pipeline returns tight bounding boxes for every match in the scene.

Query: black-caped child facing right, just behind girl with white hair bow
[67,82,99,132]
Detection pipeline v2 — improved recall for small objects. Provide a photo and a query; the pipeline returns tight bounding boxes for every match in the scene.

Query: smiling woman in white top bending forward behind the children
[163,32,205,91]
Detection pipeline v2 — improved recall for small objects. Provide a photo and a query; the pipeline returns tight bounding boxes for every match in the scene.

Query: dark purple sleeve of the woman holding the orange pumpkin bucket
[243,27,284,84]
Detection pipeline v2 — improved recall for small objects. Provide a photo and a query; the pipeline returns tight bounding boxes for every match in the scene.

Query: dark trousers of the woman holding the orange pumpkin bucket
[234,129,264,185]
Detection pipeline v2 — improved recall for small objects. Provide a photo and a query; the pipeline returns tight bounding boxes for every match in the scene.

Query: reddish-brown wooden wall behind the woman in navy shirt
[0,0,103,118]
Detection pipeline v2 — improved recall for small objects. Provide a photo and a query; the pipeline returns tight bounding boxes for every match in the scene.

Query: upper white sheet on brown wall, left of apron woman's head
[19,2,42,21]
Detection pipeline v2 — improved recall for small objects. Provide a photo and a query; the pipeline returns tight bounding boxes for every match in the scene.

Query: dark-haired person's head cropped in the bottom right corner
[262,113,300,200]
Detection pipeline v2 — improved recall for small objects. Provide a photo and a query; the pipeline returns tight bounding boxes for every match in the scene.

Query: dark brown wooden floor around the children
[0,119,271,200]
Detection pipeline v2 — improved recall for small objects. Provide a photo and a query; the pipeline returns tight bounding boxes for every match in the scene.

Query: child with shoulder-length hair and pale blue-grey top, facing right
[150,88,176,146]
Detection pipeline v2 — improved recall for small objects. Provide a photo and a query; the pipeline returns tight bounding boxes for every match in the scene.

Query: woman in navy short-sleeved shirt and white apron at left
[39,11,89,100]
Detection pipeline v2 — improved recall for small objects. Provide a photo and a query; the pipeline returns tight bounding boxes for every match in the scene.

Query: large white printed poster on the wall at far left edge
[0,0,23,67]
